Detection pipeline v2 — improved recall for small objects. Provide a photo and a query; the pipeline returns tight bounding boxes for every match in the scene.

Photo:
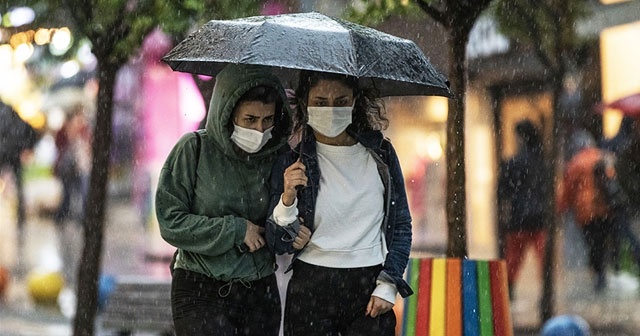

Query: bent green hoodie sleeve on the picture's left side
[155,133,247,256]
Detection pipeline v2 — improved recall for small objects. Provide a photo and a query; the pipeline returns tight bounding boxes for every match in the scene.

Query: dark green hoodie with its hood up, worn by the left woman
[156,65,291,281]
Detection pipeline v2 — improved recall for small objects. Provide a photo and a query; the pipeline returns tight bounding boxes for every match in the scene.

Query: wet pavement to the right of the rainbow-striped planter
[511,217,640,336]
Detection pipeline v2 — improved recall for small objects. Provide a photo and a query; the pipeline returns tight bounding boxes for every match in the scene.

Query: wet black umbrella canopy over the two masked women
[162,12,452,97]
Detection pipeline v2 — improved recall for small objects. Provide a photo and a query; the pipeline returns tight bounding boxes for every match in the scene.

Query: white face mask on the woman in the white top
[307,106,353,138]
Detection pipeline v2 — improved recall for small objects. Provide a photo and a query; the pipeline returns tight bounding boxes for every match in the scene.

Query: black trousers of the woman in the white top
[284,260,396,336]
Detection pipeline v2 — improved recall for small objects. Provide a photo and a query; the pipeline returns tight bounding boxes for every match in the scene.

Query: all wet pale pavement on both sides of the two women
[0,177,640,336]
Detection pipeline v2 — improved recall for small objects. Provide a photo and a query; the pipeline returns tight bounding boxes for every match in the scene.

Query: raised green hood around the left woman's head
[205,64,291,157]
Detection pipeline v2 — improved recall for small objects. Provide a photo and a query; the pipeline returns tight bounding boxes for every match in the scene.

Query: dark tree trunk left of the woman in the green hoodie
[73,61,118,336]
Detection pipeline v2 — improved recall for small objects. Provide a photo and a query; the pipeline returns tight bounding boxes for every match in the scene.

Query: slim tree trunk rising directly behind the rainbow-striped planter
[446,21,470,258]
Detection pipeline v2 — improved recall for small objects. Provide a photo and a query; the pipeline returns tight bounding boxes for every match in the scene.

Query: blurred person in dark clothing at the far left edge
[0,101,38,243]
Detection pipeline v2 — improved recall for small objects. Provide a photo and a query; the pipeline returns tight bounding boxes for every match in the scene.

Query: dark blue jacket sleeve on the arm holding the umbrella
[265,153,300,254]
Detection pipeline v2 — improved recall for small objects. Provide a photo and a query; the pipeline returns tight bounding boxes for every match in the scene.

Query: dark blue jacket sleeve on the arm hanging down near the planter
[382,142,413,297]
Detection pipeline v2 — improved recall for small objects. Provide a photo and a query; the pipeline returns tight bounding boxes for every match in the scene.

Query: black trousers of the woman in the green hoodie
[171,268,280,336]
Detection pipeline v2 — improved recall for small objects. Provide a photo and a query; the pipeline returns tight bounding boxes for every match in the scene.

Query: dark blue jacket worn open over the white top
[266,128,413,297]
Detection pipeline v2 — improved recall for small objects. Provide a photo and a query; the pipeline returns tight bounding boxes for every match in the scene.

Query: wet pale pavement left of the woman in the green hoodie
[0,176,173,336]
